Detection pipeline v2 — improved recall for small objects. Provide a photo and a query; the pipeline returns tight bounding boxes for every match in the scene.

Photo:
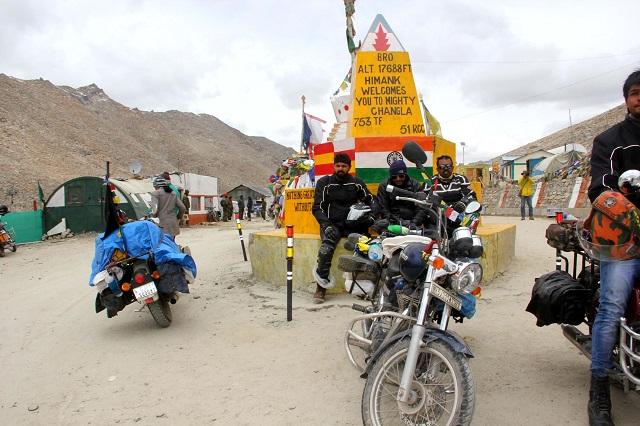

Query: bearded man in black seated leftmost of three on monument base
[312,153,373,303]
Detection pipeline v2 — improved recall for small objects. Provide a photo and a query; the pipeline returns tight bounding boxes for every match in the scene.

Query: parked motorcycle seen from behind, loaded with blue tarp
[90,220,196,328]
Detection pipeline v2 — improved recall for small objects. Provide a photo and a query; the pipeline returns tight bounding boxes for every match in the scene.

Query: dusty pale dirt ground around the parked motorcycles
[0,218,640,425]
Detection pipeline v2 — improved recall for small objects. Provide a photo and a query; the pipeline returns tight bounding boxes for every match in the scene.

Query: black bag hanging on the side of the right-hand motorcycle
[525,271,591,327]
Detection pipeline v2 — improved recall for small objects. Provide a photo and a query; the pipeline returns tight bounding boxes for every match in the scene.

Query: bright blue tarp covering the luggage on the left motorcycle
[89,220,197,286]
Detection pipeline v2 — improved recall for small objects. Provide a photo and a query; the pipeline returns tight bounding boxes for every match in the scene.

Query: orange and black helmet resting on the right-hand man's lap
[576,191,640,260]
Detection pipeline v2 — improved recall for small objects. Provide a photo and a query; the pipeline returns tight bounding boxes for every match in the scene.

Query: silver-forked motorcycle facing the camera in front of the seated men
[343,142,482,425]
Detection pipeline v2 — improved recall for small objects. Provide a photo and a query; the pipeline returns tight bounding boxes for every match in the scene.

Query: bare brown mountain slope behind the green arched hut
[0,74,294,210]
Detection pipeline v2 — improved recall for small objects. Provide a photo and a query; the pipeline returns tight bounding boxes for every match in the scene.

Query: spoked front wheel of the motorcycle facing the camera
[362,339,475,426]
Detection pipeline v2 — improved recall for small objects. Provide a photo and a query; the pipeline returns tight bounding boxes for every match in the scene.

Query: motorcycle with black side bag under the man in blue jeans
[526,170,640,392]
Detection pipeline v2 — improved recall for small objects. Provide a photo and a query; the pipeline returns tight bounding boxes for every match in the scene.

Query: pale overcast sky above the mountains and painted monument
[0,0,640,162]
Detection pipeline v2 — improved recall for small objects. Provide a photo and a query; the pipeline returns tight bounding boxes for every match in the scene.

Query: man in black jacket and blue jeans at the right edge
[588,70,640,425]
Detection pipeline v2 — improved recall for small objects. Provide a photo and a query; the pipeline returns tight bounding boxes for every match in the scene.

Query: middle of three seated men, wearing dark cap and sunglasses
[375,160,420,227]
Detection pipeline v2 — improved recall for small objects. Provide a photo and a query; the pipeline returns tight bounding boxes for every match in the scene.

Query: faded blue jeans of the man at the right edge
[591,259,640,377]
